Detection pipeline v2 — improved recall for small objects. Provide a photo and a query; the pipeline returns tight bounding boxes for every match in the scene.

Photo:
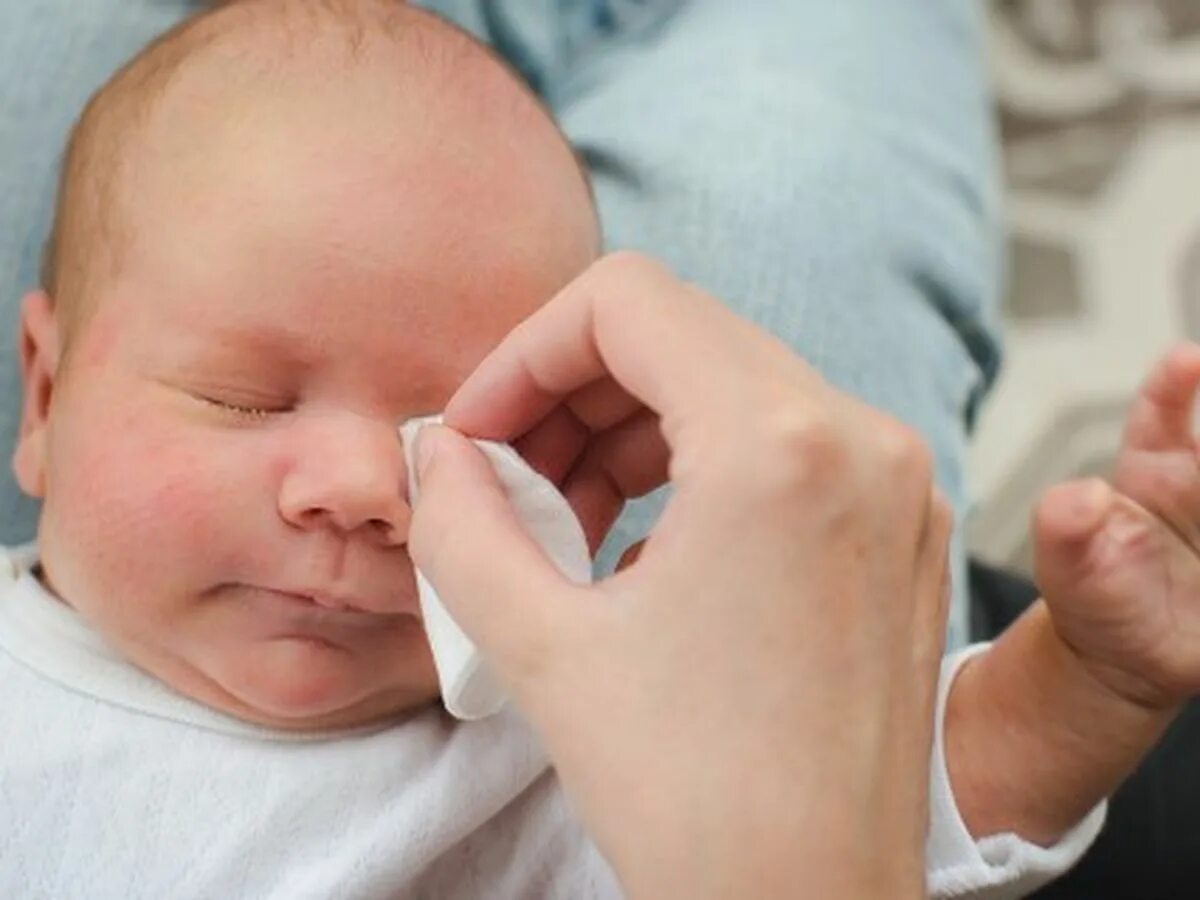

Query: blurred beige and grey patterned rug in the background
[971,0,1200,571]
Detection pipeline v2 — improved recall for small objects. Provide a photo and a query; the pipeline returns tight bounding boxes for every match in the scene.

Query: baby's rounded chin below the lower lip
[199,631,438,731]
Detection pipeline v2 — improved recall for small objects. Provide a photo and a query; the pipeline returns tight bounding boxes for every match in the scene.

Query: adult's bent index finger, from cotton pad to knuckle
[445,253,794,440]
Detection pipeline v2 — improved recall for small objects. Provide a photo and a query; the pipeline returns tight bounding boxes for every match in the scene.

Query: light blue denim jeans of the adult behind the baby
[0,0,1000,646]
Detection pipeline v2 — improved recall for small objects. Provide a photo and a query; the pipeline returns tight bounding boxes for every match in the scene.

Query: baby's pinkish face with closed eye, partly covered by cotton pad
[21,86,594,727]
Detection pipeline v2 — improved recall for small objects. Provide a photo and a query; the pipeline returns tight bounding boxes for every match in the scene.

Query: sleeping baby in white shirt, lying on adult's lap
[0,0,1200,898]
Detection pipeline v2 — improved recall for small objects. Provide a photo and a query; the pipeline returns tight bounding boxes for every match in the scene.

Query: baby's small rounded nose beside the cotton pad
[280,414,410,545]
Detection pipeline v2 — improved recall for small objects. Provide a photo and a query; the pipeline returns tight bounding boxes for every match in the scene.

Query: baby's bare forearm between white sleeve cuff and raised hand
[944,602,1174,846]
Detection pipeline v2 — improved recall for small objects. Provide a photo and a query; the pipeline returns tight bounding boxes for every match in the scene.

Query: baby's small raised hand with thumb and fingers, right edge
[1034,344,1200,709]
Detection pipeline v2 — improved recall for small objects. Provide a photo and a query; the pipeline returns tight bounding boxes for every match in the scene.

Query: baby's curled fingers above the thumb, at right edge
[1124,343,1200,451]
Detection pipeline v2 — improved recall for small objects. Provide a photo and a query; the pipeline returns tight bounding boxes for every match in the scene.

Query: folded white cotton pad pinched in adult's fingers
[400,416,592,720]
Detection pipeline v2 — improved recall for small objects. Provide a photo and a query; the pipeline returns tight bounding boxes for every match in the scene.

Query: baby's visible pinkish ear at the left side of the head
[12,290,60,497]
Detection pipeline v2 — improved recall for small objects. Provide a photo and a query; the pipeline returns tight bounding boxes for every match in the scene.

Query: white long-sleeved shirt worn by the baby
[0,550,1103,900]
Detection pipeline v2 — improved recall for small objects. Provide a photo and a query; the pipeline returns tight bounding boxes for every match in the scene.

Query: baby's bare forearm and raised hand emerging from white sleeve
[944,346,1200,845]
